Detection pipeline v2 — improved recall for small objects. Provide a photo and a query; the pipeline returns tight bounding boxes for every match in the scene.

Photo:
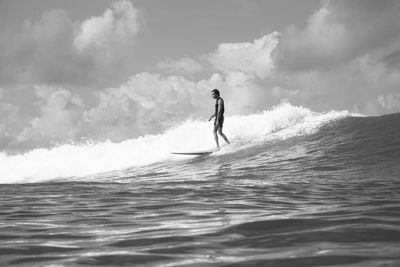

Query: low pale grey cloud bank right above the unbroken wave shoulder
[280,55,400,115]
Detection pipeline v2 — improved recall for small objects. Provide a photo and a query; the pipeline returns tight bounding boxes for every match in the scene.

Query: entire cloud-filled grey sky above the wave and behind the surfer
[0,0,400,151]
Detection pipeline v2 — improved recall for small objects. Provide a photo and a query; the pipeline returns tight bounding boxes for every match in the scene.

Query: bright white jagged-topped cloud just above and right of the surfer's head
[206,32,280,79]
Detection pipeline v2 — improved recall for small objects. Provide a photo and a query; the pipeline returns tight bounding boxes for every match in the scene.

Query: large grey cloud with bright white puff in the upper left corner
[0,1,140,88]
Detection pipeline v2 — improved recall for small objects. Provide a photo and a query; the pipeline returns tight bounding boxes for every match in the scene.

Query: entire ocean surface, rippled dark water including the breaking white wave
[0,104,400,266]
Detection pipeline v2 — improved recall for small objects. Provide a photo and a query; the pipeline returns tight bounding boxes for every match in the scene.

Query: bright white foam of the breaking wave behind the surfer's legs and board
[0,103,349,183]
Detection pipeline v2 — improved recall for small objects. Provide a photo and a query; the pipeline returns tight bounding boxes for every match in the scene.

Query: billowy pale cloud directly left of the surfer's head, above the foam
[84,73,209,139]
